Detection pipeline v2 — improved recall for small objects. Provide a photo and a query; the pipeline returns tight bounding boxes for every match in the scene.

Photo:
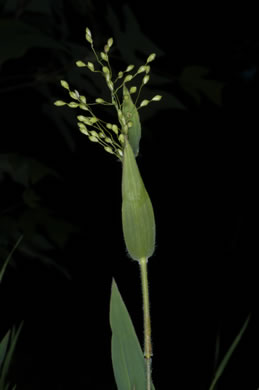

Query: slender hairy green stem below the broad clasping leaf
[139,257,153,390]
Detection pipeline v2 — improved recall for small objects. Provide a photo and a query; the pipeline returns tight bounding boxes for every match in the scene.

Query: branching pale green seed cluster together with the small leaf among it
[54,28,162,160]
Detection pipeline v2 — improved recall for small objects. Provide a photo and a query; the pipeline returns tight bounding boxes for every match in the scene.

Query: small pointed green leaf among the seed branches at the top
[122,85,141,156]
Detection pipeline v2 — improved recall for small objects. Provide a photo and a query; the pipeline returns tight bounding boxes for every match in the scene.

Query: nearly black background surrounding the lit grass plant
[0,0,259,390]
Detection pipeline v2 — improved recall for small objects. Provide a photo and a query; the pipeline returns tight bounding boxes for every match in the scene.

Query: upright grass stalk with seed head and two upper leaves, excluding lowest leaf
[54,28,162,390]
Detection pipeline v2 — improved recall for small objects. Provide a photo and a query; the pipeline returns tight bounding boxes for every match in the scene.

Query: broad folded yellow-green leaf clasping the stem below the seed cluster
[122,140,156,260]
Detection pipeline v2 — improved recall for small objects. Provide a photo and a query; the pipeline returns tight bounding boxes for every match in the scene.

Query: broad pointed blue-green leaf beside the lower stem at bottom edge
[110,279,155,390]
